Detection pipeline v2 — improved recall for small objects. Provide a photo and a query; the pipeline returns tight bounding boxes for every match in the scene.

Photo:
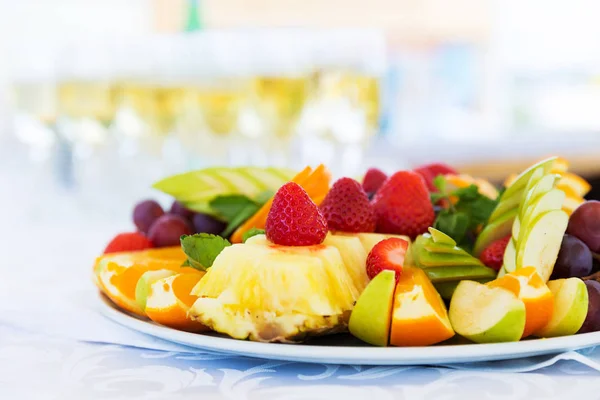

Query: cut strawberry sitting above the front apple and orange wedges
[367,238,408,282]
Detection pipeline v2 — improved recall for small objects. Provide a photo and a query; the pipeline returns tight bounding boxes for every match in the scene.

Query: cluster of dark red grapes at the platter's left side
[133,200,225,247]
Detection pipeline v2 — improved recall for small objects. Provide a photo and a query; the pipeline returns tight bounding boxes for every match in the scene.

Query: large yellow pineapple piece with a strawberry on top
[189,238,360,342]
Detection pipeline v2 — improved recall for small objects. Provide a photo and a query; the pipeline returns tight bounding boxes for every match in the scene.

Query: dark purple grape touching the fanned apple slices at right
[550,235,594,279]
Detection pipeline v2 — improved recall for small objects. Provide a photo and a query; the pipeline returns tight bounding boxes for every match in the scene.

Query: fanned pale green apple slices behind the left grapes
[153,167,293,214]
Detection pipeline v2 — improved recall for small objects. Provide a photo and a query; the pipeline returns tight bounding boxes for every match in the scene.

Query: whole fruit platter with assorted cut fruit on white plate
[93,157,600,364]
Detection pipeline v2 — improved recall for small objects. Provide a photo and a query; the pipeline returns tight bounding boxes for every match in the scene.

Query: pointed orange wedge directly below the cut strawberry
[390,267,454,346]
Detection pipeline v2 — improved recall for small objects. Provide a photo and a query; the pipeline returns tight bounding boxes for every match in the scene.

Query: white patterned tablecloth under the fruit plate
[0,140,600,400]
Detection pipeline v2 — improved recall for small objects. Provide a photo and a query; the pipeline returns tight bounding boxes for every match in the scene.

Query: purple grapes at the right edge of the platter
[551,200,600,333]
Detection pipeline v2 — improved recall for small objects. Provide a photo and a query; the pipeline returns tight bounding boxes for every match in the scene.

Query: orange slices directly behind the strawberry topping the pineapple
[231,164,331,243]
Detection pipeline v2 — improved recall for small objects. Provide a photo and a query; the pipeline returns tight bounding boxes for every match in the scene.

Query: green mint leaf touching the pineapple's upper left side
[180,233,231,271]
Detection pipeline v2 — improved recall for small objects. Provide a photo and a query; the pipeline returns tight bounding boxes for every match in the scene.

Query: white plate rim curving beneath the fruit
[100,294,600,365]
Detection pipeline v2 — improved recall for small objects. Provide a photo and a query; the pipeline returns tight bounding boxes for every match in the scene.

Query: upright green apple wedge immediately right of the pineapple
[348,270,398,346]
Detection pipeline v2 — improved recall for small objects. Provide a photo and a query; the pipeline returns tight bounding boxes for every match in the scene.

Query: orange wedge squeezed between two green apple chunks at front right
[487,267,554,337]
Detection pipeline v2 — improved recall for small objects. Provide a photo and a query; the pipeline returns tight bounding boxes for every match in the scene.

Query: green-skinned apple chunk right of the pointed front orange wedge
[449,281,526,343]
